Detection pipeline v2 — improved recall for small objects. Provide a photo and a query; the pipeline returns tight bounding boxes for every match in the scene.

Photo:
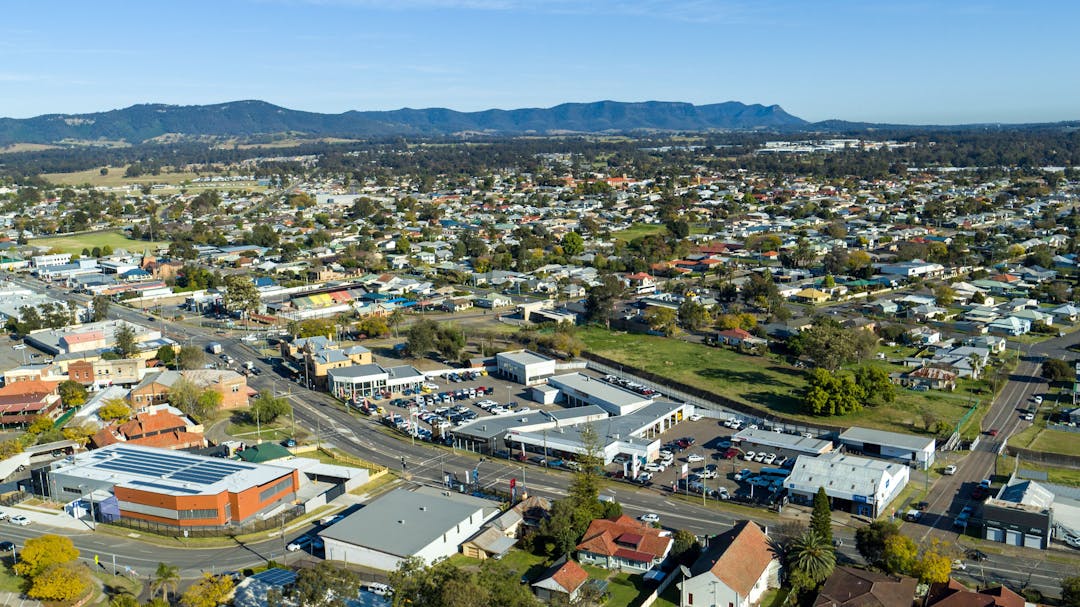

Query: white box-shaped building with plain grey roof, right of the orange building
[319,487,501,571]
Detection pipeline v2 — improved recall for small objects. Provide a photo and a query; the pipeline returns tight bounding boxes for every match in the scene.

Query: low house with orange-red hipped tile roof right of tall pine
[576,514,673,572]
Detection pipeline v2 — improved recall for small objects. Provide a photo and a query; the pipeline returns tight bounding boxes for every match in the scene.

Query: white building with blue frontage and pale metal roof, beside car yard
[784,451,910,517]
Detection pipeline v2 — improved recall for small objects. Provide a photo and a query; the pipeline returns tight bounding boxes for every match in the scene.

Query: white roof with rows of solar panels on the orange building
[50,443,292,496]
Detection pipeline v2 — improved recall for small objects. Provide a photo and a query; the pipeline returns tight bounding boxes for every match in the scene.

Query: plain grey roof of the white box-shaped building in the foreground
[319,481,499,557]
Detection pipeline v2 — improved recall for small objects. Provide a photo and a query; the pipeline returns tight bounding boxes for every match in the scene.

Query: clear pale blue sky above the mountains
[0,0,1080,123]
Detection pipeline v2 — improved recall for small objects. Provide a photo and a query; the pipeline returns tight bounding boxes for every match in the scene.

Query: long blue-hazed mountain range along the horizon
[0,100,1077,146]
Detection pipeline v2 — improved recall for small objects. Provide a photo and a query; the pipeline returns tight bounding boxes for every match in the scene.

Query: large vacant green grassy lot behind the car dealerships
[580,327,987,433]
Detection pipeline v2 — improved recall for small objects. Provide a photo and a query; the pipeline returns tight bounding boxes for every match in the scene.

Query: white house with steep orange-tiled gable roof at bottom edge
[679,514,780,607]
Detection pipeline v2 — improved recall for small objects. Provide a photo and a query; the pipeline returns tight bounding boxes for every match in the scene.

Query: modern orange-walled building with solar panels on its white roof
[48,444,300,527]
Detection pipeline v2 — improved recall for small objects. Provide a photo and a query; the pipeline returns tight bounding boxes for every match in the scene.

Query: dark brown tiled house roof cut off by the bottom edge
[813,566,918,607]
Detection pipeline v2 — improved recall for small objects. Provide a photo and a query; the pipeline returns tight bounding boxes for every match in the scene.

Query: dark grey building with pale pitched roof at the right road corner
[983,477,1054,549]
